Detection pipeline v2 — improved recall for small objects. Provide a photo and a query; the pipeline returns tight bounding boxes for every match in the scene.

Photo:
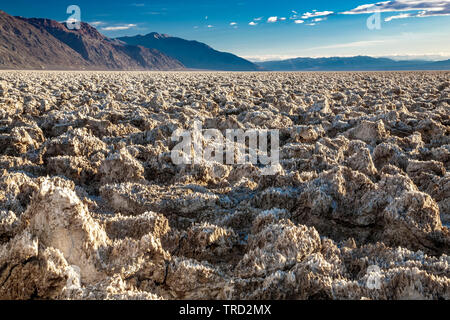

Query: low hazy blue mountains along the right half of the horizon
[258,56,450,71]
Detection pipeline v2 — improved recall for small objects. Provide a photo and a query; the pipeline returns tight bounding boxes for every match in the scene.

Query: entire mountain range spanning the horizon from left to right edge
[0,10,450,71]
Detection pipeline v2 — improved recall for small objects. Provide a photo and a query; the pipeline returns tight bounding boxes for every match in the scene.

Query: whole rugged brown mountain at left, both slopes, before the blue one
[0,11,184,70]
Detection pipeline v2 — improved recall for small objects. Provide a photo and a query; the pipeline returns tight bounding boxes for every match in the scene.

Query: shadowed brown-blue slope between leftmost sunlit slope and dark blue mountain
[23,18,183,70]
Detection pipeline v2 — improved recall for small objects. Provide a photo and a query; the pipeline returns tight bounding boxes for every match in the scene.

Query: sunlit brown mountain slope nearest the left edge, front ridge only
[0,11,89,69]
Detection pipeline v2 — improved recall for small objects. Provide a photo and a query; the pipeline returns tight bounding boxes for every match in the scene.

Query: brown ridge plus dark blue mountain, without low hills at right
[0,11,261,71]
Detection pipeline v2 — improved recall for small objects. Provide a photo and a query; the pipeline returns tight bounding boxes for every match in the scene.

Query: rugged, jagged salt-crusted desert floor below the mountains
[0,71,450,299]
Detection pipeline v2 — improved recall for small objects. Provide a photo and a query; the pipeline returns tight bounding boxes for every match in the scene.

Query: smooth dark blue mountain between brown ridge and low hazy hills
[118,33,261,71]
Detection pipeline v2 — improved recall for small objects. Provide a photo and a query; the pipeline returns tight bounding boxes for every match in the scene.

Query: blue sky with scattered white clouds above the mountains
[0,0,450,61]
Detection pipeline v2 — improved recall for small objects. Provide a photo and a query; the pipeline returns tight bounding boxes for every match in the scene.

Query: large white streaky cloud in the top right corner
[342,0,450,21]
